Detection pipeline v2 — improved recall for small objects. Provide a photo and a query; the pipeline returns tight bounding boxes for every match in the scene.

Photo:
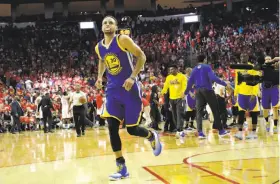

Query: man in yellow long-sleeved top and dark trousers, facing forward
[161,65,187,138]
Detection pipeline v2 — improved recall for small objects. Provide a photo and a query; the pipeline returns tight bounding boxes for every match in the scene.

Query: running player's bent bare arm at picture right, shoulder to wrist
[119,35,146,78]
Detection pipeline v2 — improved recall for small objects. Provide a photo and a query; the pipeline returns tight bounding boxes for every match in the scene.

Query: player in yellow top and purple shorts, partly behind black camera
[234,53,261,140]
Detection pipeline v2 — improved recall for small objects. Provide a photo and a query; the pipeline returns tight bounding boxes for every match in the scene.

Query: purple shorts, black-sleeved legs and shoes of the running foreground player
[104,87,162,180]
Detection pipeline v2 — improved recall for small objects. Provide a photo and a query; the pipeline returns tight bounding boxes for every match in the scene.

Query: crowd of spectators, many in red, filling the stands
[0,0,279,132]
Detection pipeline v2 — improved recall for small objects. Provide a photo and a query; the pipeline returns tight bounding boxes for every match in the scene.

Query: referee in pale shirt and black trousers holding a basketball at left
[69,84,88,137]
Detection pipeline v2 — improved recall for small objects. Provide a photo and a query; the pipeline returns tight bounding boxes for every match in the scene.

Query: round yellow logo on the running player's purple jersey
[104,53,122,75]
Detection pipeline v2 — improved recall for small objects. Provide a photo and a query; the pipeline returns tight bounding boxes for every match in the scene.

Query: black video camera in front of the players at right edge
[230,56,279,88]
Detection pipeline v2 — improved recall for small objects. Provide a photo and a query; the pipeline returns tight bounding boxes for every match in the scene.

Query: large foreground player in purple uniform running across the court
[95,16,162,180]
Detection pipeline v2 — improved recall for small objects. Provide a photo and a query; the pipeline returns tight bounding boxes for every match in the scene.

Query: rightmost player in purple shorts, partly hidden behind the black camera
[262,56,280,133]
